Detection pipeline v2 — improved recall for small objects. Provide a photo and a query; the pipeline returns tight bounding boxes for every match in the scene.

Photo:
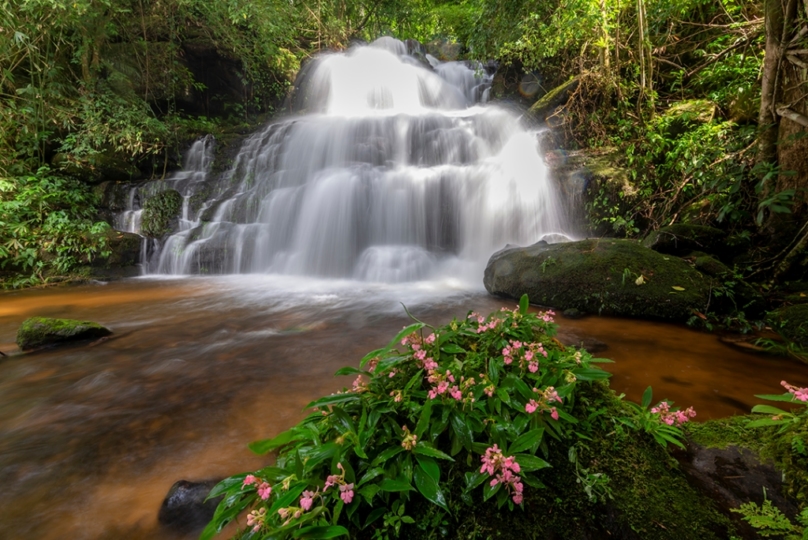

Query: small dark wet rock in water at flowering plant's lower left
[157,480,221,533]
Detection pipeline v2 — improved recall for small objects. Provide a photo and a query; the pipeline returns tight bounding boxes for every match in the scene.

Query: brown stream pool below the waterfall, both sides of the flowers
[0,276,808,540]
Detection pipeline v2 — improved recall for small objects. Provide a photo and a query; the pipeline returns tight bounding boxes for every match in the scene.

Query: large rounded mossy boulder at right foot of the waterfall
[483,238,714,321]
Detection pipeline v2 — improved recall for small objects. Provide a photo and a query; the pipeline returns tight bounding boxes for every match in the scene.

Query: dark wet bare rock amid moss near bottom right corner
[674,442,797,540]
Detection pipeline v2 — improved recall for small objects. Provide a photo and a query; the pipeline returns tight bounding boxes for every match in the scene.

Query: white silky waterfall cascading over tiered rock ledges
[123,38,565,282]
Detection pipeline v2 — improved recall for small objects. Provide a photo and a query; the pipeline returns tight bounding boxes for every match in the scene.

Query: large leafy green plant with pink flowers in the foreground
[202,296,624,539]
